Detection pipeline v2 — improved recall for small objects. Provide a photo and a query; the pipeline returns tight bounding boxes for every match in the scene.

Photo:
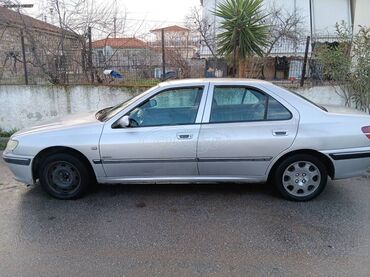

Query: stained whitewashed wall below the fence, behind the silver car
[0,85,344,130]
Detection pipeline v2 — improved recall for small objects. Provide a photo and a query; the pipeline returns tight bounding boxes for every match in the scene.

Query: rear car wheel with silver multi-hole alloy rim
[272,154,328,201]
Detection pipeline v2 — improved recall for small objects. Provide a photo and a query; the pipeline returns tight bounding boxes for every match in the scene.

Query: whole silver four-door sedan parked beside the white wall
[3,79,370,201]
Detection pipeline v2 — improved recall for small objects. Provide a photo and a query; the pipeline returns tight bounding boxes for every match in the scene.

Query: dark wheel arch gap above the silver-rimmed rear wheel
[268,149,335,180]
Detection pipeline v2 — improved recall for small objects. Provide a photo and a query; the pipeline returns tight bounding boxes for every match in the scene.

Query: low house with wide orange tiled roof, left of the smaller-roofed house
[92,37,161,78]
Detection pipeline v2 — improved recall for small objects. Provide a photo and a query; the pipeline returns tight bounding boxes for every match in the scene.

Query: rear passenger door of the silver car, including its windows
[197,85,299,179]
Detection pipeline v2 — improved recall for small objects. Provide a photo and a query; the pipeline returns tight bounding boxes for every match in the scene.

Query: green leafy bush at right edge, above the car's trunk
[316,23,370,112]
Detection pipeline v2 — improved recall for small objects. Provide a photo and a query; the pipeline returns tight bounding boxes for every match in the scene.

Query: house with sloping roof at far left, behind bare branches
[0,6,83,83]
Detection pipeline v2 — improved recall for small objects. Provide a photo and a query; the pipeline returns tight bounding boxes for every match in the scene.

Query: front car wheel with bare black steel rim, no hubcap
[39,153,90,200]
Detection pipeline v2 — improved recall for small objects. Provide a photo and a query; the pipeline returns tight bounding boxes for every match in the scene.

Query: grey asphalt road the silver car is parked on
[0,153,370,276]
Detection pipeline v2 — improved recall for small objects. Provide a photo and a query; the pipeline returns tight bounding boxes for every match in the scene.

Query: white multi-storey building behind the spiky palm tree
[200,0,370,79]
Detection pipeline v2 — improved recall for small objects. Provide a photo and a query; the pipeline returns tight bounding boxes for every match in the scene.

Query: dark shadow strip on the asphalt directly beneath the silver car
[20,181,352,219]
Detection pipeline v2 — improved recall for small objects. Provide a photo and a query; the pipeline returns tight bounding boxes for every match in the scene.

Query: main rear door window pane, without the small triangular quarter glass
[210,87,268,122]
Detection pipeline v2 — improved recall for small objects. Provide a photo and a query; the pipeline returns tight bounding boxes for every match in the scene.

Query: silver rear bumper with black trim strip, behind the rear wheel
[323,147,370,179]
